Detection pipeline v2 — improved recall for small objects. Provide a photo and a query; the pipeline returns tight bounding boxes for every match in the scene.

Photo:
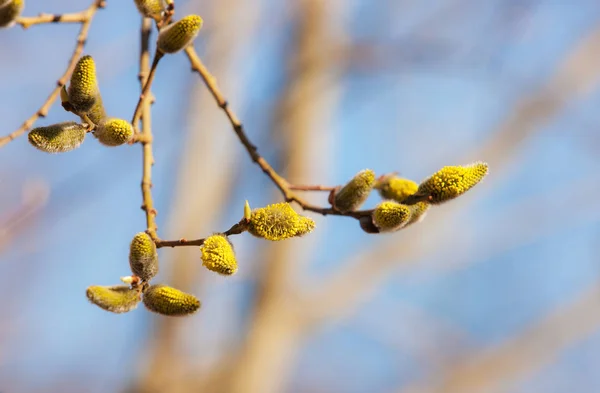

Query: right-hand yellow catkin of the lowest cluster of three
[143,284,200,316]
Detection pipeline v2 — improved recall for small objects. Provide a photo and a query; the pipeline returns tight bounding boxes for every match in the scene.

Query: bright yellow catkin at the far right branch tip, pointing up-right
[404,162,488,205]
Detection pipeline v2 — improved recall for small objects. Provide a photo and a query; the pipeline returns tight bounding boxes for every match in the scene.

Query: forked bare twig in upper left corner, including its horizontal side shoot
[0,0,105,147]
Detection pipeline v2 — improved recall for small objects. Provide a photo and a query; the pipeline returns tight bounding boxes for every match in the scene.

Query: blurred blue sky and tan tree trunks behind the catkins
[0,0,600,393]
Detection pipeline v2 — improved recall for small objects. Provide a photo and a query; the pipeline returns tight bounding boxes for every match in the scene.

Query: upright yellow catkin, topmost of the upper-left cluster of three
[67,55,99,114]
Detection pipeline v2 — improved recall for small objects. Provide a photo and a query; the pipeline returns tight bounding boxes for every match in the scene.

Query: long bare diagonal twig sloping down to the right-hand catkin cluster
[185,45,372,219]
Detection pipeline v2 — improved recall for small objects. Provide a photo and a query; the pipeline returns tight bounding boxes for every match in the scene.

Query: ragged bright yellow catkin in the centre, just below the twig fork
[248,202,315,241]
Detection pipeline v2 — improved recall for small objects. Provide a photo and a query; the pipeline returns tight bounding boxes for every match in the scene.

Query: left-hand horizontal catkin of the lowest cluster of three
[86,285,141,314]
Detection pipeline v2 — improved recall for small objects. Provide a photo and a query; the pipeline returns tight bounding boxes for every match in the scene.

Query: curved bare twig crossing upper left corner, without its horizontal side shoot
[0,0,104,147]
